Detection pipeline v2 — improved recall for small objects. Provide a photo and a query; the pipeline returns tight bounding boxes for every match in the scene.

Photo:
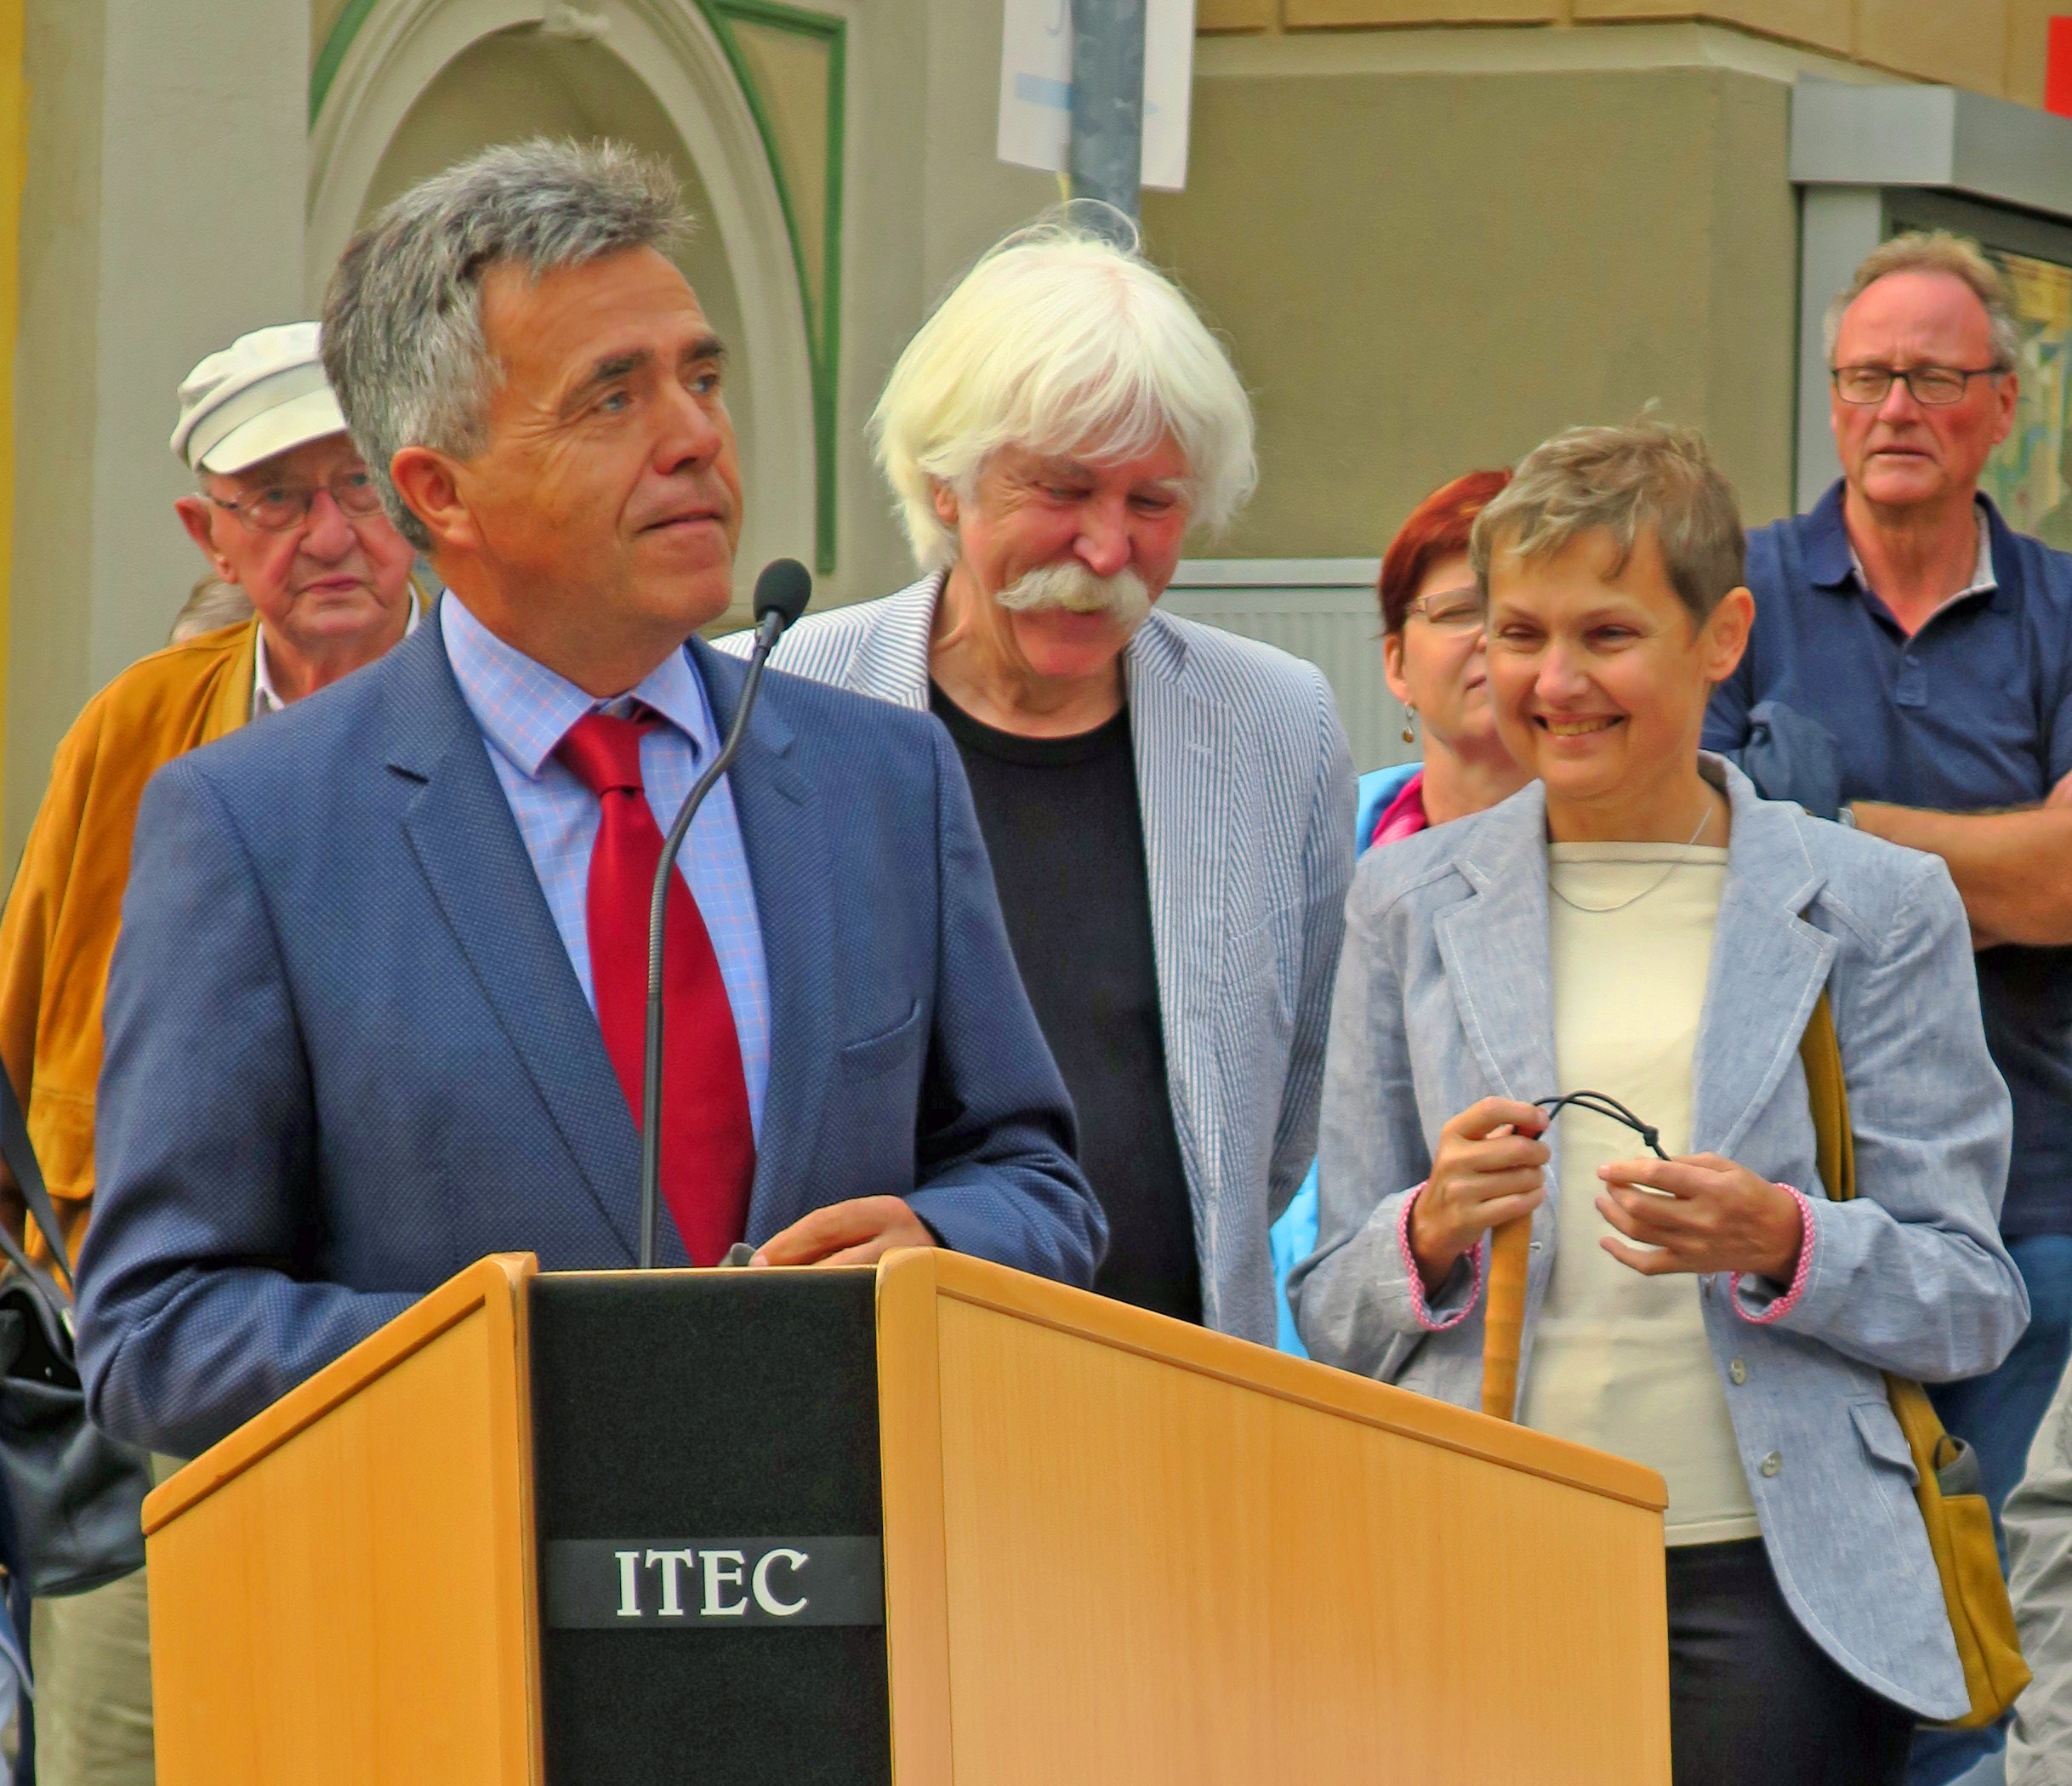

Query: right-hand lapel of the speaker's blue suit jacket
[690,640,833,1239]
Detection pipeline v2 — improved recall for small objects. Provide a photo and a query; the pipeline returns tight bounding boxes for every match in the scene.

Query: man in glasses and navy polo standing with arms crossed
[1705,234,2072,1786]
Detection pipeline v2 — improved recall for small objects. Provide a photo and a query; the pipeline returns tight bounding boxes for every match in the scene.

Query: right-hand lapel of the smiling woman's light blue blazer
[1691,766,1836,1158]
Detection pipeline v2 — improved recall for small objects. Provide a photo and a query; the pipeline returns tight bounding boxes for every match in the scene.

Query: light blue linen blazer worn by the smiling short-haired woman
[1289,756,2029,1718]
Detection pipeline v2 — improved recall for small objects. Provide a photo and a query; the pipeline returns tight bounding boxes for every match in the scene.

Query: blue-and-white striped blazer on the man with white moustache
[719,574,1353,1345]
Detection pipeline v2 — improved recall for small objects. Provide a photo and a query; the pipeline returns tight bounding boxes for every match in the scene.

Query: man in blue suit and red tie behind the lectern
[79,132,1107,1454]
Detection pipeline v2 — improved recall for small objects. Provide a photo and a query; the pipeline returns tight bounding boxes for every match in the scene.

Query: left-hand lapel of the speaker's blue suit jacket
[388,626,646,1264]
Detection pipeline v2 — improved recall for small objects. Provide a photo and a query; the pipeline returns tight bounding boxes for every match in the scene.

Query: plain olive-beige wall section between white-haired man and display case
[1144,25,1873,557]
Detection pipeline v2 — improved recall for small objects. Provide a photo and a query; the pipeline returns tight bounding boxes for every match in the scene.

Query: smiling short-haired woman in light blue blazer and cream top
[1289,423,2029,1786]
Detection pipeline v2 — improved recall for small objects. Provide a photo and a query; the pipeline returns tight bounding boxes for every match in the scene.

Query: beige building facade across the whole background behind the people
[0,0,2056,858]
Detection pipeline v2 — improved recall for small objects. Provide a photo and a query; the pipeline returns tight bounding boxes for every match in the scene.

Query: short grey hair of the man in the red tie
[323,137,690,551]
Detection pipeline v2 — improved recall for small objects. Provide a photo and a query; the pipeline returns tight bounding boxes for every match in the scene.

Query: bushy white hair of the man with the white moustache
[870,208,1258,570]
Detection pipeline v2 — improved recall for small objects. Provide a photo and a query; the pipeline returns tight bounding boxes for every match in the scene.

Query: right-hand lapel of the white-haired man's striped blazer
[1123,611,1232,1229]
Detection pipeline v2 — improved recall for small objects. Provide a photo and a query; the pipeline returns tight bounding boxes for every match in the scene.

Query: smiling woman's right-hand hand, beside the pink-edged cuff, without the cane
[1597,1154,1805,1284]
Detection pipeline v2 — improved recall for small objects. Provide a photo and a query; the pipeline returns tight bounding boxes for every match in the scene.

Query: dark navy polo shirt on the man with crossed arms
[1705,483,2072,1237]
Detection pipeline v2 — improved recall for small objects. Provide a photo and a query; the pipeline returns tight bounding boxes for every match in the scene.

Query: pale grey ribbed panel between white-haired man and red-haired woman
[1158,557,1420,773]
